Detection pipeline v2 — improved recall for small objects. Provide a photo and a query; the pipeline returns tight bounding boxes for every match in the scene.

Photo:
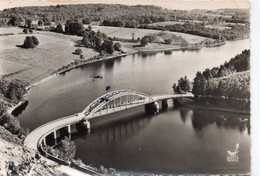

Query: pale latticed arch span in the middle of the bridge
[82,90,154,117]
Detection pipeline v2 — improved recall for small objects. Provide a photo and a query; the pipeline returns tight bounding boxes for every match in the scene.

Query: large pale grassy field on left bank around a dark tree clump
[0,29,98,83]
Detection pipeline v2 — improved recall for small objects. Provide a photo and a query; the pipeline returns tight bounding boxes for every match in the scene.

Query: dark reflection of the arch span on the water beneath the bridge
[78,107,154,143]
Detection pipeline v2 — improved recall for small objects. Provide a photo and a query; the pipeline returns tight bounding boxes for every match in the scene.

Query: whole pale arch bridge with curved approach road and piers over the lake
[24,90,193,173]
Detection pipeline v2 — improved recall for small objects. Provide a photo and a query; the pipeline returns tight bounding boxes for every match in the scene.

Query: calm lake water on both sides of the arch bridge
[15,40,251,173]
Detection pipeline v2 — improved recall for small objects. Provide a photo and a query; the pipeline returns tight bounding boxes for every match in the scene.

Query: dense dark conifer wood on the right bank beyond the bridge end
[192,50,250,109]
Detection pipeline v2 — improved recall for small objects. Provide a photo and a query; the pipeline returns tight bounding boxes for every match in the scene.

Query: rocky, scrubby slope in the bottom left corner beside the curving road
[0,126,62,175]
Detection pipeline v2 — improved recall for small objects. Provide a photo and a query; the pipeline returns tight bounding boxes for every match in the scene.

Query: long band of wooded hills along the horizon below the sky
[0,4,250,27]
